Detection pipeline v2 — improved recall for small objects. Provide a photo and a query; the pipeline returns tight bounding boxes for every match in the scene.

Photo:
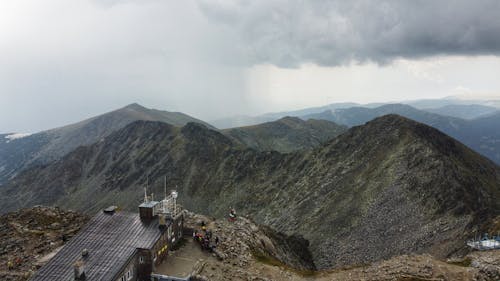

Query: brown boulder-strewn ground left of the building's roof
[0,207,88,281]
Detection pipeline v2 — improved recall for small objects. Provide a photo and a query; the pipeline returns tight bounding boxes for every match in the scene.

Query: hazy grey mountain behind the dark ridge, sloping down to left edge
[0,104,210,185]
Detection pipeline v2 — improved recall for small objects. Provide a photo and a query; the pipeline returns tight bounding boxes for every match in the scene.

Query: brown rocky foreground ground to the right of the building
[184,213,500,281]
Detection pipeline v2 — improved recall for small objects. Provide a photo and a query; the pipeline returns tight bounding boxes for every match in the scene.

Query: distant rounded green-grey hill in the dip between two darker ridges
[222,117,347,152]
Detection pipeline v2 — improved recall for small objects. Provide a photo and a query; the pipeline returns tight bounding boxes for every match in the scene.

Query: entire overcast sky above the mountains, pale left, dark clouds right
[0,0,500,132]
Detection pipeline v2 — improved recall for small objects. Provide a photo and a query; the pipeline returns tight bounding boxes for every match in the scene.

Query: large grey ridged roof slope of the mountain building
[31,209,162,281]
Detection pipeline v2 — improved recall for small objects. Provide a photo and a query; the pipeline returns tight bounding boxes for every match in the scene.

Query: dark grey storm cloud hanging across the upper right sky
[198,0,500,67]
